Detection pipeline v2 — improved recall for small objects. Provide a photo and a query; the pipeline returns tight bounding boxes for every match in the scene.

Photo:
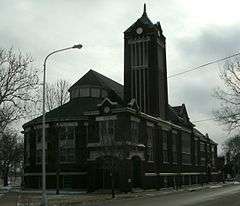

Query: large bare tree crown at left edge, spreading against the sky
[0,48,39,131]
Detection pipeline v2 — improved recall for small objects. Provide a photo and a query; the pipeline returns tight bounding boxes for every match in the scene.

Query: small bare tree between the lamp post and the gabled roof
[46,79,70,111]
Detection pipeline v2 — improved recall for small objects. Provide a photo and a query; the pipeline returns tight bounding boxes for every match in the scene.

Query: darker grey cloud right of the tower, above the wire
[176,24,240,62]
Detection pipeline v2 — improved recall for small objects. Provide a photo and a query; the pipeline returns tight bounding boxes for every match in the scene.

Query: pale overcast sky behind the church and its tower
[0,0,240,153]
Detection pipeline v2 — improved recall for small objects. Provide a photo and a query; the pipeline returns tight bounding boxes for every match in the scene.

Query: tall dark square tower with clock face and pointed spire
[124,4,168,119]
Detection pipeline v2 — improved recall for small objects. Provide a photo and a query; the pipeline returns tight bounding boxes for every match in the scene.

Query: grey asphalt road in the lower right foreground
[92,185,240,206]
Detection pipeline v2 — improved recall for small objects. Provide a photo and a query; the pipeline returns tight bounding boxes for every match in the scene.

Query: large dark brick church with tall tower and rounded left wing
[23,5,218,191]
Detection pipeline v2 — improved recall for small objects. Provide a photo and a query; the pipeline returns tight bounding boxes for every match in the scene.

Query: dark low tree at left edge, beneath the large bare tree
[0,129,23,186]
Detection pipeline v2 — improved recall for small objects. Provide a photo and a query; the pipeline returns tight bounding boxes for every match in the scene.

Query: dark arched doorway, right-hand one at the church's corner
[132,157,141,187]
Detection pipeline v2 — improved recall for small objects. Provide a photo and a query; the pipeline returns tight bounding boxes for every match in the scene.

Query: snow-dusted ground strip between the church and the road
[17,182,237,206]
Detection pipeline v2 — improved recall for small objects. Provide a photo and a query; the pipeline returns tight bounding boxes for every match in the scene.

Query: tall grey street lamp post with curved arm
[42,44,82,206]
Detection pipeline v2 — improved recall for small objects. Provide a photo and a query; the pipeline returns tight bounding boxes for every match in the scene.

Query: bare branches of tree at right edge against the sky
[213,58,240,131]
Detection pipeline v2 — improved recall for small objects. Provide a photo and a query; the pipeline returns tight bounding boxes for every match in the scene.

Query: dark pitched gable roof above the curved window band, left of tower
[69,70,123,99]
